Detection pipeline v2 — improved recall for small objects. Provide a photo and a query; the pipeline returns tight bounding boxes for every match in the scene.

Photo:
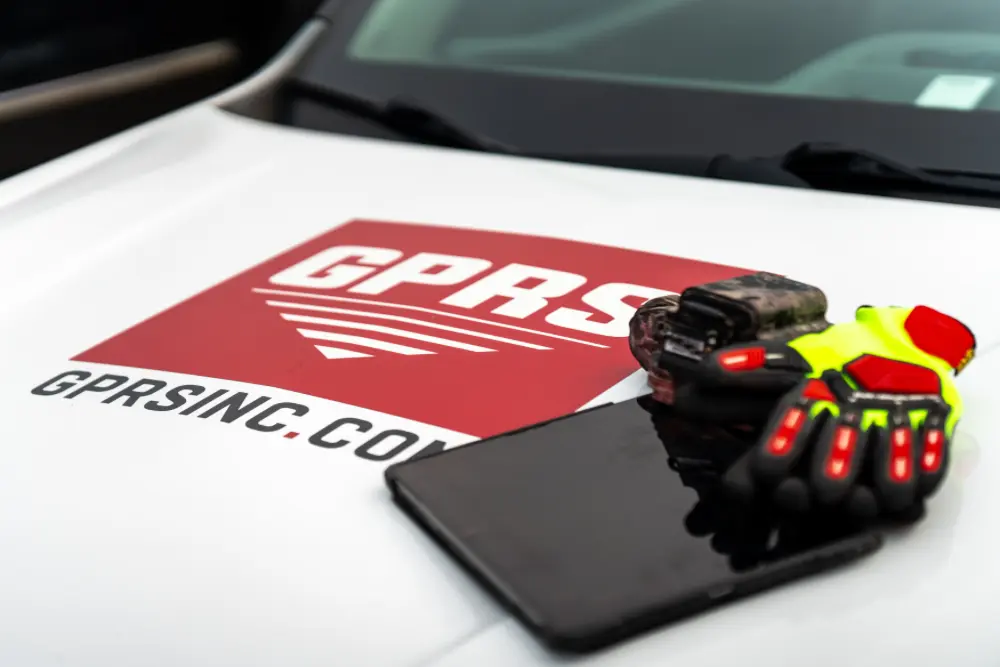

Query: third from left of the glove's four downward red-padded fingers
[868,411,917,513]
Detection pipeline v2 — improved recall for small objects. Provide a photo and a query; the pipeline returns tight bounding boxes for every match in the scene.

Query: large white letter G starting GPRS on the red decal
[271,245,403,289]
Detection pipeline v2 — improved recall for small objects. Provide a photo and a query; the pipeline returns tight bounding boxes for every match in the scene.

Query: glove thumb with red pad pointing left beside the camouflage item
[661,341,812,392]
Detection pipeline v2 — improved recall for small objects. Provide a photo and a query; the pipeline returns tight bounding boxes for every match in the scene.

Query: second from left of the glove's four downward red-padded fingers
[809,409,867,505]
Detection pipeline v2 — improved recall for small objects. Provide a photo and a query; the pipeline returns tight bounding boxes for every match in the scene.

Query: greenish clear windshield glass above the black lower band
[349,0,1000,110]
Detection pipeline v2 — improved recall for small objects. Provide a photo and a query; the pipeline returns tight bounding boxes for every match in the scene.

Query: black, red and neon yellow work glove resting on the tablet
[659,306,975,518]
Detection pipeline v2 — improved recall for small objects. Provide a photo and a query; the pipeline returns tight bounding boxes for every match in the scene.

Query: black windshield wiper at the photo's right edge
[777,142,1000,197]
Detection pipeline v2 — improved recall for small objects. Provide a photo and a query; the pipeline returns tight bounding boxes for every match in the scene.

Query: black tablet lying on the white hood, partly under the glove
[386,397,881,652]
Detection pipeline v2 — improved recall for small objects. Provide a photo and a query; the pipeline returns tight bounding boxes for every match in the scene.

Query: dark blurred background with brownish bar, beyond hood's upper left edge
[0,0,320,178]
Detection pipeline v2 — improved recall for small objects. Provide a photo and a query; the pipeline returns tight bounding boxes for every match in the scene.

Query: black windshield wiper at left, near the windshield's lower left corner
[286,84,520,155]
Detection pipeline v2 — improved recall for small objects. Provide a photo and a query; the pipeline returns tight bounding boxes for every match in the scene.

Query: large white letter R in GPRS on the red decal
[441,264,587,318]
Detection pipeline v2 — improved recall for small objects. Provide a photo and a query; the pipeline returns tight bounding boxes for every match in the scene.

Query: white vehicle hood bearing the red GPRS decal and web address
[0,107,1000,667]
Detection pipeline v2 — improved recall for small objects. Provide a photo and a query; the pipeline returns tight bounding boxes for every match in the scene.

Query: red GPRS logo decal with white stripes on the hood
[76,221,749,437]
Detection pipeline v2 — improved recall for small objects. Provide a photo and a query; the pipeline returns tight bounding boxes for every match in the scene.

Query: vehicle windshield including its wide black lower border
[274,0,1000,185]
